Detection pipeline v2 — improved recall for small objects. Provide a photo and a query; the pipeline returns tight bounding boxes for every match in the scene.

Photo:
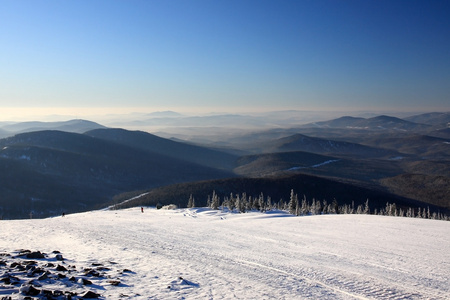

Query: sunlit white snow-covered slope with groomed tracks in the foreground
[0,208,450,299]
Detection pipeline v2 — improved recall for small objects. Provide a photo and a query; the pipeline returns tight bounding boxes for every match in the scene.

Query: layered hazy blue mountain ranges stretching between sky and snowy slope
[0,112,450,218]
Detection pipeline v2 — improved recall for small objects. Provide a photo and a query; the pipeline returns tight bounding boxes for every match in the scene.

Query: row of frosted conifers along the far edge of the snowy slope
[187,189,450,221]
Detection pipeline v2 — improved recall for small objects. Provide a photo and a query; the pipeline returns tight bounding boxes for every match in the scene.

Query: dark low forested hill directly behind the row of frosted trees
[110,174,438,210]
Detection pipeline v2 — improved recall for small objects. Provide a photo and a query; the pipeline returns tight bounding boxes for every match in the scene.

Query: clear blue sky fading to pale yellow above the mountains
[0,0,450,120]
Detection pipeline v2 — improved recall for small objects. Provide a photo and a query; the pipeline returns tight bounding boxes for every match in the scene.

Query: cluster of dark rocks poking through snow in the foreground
[0,250,132,300]
